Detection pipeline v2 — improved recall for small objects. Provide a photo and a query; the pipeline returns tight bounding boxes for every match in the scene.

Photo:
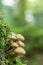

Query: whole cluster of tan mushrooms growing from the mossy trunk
[7,32,26,57]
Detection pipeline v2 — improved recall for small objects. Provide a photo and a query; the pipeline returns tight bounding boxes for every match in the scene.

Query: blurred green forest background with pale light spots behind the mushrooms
[0,0,43,65]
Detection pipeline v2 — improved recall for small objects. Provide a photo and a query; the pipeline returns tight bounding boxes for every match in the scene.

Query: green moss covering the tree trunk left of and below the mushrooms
[0,16,26,65]
